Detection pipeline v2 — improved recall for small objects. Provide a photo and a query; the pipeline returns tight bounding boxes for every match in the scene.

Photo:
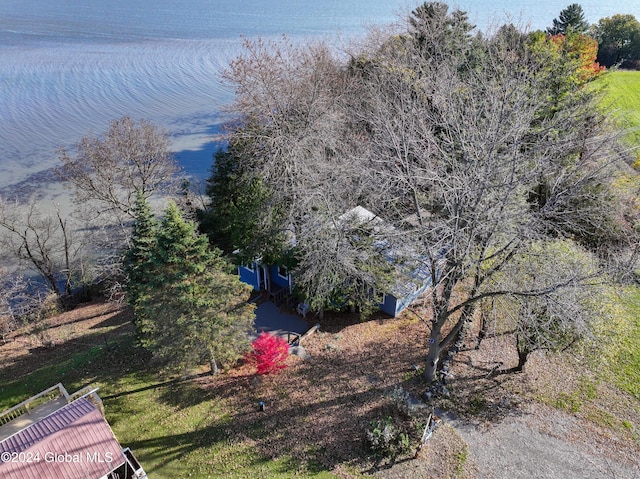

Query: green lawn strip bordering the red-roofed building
[0,337,336,479]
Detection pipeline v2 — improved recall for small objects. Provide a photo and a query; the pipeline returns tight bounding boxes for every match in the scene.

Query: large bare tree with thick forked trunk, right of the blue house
[352,11,623,380]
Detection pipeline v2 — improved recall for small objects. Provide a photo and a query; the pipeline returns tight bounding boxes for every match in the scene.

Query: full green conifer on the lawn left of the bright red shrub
[134,203,255,374]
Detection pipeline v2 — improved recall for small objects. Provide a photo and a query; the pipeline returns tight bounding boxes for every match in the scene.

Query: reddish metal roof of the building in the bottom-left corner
[0,398,125,479]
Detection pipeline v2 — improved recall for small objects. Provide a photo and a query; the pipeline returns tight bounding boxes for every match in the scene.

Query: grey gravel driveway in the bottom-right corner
[445,405,640,479]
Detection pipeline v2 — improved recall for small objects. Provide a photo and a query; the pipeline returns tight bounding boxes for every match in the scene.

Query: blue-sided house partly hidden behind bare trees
[238,206,431,317]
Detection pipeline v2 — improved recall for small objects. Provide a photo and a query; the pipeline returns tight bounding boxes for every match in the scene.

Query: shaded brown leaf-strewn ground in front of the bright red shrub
[195,322,432,470]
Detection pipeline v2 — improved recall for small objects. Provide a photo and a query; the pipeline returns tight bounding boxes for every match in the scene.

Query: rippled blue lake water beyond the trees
[0,0,640,195]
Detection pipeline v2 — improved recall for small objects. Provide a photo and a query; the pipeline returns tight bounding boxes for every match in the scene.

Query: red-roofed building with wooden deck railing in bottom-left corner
[0,384,147,479]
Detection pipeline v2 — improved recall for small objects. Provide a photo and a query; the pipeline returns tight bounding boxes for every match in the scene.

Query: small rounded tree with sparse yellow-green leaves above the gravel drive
[493,240,607,373]
